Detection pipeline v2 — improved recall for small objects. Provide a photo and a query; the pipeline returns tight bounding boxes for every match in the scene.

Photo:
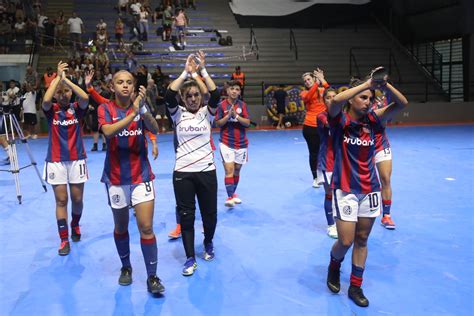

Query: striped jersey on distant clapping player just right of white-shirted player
[215,99,249,149]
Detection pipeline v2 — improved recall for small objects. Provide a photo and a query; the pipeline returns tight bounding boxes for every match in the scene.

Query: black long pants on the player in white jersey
[173,170,217,258]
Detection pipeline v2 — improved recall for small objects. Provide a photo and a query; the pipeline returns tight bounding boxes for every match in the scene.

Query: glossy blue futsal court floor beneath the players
[0,125,474,316]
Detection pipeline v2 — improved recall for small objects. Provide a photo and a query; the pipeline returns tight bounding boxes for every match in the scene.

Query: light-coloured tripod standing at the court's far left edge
[0,108,47,204]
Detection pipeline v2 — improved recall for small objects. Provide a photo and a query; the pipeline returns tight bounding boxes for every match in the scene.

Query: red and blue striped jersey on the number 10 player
[330,111,382,194]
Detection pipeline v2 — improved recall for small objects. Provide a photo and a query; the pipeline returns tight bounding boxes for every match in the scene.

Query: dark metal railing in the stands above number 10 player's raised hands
[349,47,402,84]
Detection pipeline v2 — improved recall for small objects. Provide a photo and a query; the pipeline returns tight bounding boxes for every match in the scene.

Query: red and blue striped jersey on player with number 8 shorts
[98,101,155,185]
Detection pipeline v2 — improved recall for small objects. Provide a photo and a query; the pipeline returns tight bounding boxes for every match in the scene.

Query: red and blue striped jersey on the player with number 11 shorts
[43,102,87,162]
